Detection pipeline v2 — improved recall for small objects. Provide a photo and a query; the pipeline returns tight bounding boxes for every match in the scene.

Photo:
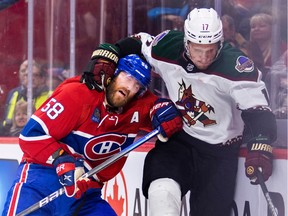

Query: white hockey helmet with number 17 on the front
[184,8,223,44]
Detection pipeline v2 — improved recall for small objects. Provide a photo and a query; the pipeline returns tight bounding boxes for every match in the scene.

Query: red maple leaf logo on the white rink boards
[103,171,128,216]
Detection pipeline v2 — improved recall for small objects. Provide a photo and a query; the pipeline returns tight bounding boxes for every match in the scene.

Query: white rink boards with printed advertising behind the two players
[0,138,288,216]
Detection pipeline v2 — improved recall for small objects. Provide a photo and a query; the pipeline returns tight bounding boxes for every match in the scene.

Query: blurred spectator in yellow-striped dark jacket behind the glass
[1,60,52,134]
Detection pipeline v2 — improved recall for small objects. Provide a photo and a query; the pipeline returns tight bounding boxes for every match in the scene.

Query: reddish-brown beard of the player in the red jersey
[106,80,133,108]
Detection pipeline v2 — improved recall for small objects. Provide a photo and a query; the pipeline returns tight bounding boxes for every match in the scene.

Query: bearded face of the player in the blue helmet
[106,72,141,107]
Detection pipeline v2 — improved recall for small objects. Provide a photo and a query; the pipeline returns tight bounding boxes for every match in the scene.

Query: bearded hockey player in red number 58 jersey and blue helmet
[2,55,182,216]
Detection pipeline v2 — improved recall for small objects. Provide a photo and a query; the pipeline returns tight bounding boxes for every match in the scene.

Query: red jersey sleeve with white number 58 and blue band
[19,78,101,164]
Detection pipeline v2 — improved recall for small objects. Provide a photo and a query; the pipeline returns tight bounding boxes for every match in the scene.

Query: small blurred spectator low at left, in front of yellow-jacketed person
[8,100,30,137]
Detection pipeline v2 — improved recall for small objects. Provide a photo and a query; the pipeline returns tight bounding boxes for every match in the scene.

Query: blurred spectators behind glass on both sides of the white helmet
[147,0,288,119]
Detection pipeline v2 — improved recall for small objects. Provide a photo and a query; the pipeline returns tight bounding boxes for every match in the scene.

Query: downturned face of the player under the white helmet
[188,42,219,70]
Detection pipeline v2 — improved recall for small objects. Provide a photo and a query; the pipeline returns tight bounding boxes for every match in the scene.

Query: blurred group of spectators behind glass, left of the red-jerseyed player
[0,60,69,136]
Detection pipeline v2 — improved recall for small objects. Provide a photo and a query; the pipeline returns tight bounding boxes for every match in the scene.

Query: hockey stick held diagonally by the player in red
[16,128,160,216]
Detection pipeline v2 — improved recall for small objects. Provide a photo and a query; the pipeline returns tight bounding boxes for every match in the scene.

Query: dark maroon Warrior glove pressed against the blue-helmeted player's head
[80,43,119,91]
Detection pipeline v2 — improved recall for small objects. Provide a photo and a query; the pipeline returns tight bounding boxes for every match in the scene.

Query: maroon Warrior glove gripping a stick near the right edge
[245,136,273,184]
